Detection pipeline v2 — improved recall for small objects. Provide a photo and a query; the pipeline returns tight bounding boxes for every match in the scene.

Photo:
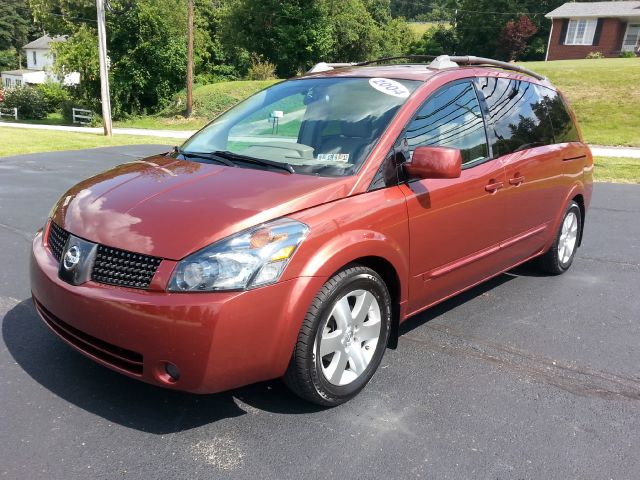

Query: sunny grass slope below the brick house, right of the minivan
[522,58,640,146]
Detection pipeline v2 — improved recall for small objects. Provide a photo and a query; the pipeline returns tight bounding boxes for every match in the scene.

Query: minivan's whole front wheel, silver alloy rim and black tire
[284,266,391,406]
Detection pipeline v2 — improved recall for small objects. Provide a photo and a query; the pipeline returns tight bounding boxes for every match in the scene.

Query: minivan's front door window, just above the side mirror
[405,82,488,164]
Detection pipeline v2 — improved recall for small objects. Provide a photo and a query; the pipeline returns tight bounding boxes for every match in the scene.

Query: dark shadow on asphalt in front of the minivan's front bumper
[2,299,321,434]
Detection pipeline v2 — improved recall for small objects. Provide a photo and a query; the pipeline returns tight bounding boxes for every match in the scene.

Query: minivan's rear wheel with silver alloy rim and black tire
[538,201,582,275]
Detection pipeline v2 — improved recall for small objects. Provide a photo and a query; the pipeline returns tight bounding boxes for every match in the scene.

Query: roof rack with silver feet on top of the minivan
[308,55,547,80]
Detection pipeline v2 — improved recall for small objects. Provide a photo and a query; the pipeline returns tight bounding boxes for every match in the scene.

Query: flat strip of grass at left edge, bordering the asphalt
[0,126,184,157]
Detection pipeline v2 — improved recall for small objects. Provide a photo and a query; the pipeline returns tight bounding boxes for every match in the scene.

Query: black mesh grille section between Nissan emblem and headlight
[91,245,162,289]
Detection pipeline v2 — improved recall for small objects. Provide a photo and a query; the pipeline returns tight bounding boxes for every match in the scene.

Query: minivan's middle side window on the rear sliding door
[474,77,554,157]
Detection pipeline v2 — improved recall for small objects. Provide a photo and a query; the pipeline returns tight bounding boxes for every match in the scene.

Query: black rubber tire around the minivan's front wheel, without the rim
[284,265,391,407]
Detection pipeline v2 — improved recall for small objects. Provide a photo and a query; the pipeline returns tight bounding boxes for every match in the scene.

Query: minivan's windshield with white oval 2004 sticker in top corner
[181,78,420,176]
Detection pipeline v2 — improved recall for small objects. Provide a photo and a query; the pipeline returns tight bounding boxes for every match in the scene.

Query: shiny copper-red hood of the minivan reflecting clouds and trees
[53,156,350,260]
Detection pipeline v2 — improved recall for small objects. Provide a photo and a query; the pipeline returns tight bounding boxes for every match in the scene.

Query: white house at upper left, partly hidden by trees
[0,35,80,88]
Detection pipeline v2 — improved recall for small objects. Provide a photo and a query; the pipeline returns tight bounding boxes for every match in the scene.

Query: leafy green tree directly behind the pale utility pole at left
[40,0,187,118]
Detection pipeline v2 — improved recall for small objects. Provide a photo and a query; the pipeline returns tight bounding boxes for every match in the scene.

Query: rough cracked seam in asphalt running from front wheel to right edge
[400,325,640,400]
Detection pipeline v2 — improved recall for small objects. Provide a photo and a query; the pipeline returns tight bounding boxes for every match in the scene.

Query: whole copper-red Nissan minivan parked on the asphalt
[31,57,593,406]
